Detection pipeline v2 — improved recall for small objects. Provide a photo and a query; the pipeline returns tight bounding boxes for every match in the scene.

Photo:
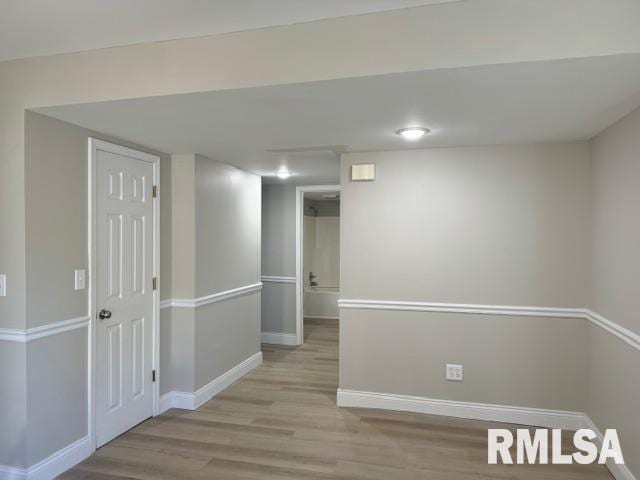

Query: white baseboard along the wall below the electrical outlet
[337,389,584,430]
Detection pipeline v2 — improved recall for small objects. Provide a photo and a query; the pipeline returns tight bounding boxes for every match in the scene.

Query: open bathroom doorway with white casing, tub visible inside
[296,185,340,345]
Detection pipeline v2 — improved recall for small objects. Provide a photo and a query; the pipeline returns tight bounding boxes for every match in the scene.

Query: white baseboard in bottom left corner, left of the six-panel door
[0,436,93,480]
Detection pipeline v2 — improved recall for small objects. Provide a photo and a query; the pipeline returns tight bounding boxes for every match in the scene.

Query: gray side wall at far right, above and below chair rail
[587,109,640,475]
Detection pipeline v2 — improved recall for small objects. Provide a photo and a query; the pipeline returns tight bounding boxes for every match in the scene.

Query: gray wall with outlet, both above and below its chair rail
[340,142,589,410]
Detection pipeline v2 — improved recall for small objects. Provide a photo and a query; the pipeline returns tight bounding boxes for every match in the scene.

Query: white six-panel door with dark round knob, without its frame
[94,142,154,447]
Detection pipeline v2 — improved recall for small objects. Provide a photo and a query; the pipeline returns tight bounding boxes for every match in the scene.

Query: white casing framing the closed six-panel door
[87,137,160,451]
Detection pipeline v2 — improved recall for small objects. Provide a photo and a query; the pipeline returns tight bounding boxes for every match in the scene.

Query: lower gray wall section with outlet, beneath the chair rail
[340,309,587,411]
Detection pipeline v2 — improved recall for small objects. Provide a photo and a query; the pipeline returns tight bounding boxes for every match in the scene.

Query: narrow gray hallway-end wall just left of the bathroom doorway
[262,184,296,334]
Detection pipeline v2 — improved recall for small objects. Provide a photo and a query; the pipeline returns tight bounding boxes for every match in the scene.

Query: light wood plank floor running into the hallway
[62,319,613,480]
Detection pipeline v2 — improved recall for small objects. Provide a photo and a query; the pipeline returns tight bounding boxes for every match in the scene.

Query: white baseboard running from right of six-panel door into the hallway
[160,352,262,412]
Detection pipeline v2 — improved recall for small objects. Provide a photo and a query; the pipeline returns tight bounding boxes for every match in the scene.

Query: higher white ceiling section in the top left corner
[0,0,460,61]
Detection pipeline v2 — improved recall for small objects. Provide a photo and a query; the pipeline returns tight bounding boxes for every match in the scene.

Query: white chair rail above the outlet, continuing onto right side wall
[338,299,640,350]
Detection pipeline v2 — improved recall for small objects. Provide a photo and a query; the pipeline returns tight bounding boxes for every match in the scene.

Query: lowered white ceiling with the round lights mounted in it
[38,55,640,184]
